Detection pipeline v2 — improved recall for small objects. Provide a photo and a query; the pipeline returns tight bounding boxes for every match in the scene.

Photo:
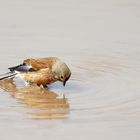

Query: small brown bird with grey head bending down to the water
[0,57,71,87]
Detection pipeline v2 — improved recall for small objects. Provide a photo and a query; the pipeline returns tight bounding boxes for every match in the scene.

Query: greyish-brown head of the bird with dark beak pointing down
[52,61,71,86]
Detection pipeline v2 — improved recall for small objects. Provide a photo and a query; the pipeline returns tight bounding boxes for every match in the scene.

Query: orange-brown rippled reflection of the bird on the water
[0,79,69,119]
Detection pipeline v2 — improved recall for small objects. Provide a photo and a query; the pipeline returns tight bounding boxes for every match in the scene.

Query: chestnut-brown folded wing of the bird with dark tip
[8,57,58,72]
